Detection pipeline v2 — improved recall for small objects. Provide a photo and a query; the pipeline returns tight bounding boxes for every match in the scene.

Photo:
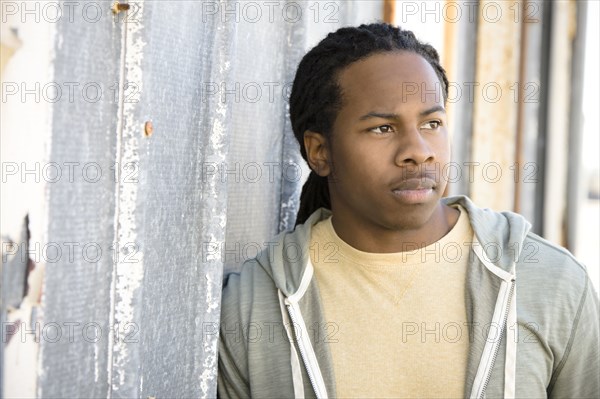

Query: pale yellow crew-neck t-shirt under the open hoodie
[310,206,473,398]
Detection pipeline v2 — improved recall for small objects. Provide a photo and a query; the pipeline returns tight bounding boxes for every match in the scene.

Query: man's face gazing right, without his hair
[328,52,450,236]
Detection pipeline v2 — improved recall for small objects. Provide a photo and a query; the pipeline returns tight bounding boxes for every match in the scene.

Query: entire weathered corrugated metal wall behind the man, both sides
[0,0,599,398]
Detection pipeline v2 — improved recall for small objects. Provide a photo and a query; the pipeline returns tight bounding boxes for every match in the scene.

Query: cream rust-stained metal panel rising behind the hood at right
[472,1,522,210]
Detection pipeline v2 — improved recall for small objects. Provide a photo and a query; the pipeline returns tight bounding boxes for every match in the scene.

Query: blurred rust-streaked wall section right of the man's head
[394,0,600,288]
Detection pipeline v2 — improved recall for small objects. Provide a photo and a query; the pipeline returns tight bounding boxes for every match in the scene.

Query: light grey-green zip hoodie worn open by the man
[218,196,600,398]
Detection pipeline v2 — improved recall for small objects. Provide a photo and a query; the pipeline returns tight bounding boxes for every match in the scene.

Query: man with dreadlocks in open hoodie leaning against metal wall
[218,24,600,398]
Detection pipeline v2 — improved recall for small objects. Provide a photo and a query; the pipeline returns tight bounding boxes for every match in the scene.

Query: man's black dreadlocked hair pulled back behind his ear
[290,23,448,225]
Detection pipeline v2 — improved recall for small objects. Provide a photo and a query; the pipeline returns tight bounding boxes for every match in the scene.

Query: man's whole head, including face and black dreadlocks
[290,24,450,245]
